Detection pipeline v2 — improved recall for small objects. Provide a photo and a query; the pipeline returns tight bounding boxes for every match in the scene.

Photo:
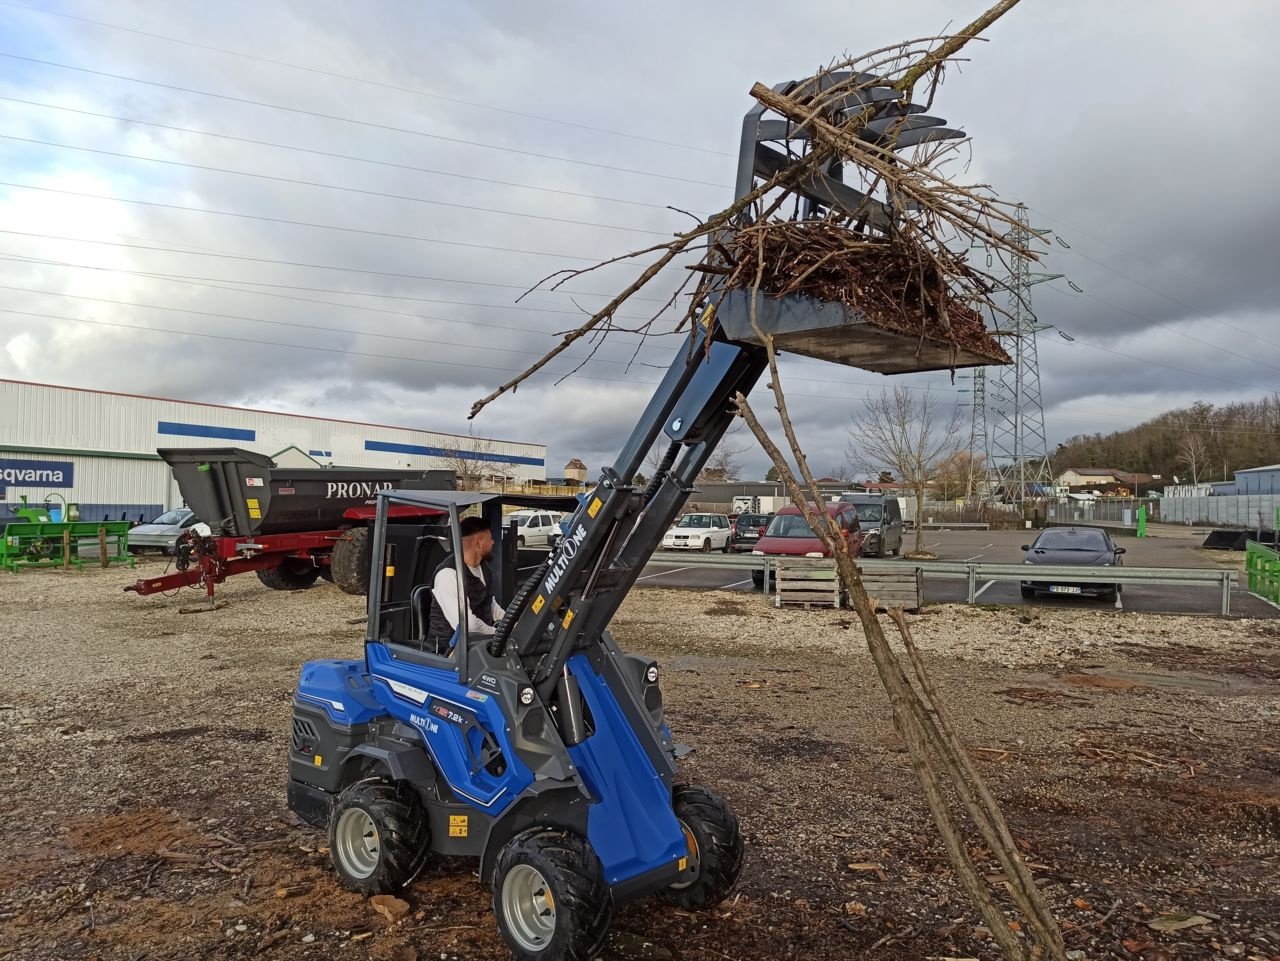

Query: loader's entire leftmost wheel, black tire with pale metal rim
[329,778,429,897]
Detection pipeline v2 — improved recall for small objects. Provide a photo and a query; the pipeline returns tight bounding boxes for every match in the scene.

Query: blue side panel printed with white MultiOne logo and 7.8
[366,644,534,818]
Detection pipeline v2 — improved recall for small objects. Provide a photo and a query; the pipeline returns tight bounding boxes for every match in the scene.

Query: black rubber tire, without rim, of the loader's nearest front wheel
[493,828,613,961]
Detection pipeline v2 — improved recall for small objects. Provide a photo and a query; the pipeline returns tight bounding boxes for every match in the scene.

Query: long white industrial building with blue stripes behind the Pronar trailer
[0,379,547,521]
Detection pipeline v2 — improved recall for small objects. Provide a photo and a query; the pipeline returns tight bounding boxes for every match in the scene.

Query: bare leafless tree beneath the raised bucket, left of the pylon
[847,386,961,553]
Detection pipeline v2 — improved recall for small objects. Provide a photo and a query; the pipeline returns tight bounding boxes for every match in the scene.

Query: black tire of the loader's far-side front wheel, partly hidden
[658,784,742,911]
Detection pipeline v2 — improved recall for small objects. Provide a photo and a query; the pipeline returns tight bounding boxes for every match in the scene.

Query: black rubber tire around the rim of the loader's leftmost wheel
[329,778,430,897]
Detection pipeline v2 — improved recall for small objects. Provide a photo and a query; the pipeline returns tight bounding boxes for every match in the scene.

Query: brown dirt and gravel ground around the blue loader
[0,571,1280,961]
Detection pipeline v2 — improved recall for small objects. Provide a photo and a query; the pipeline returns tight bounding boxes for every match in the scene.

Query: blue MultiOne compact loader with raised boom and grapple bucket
[288,73,993,961]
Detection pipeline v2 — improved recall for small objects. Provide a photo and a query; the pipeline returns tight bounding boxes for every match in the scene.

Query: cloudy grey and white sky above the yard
[0,0,1280,477]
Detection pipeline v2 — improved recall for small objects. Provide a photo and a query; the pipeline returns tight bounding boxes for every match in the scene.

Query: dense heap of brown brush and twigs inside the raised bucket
[716,219,1010,363]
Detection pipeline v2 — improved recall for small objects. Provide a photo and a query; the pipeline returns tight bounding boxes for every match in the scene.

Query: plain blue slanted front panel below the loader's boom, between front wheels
[568,654,689,884]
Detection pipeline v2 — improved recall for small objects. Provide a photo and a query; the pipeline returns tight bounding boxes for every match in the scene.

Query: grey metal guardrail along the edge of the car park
[649,548,1239,617]
